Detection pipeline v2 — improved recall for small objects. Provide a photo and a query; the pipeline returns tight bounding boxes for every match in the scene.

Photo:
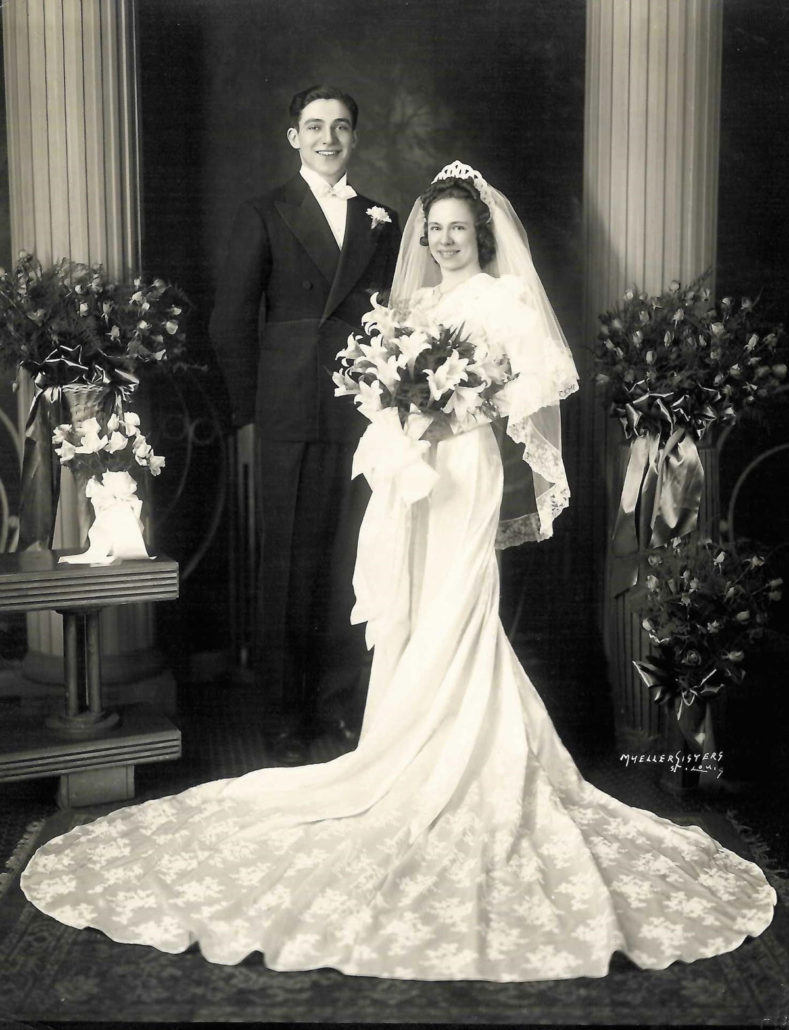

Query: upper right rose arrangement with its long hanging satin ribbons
[592,276,787,592]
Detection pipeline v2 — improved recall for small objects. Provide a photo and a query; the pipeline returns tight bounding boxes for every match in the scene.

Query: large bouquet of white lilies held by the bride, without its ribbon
[332,294,514,433]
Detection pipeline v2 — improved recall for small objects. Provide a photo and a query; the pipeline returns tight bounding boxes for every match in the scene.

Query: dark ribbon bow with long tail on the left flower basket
[19,344,139,551]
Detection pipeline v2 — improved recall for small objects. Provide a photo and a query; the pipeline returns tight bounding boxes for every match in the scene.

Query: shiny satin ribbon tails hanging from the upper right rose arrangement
[612,425,705,596]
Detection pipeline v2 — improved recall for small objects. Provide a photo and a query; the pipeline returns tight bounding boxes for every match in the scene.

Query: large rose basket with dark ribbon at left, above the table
[0,251,192,549]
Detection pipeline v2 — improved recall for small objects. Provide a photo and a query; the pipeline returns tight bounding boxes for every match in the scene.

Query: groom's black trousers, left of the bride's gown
[255,435,371,730]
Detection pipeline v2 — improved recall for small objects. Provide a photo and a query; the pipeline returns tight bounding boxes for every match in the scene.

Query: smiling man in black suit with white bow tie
[210,85,400,764]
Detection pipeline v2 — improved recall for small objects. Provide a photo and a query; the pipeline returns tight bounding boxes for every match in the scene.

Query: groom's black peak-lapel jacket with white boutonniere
[210,175,400,443]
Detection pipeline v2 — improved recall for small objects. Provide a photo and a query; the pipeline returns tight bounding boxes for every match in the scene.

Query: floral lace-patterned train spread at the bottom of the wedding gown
[26,737,775,981]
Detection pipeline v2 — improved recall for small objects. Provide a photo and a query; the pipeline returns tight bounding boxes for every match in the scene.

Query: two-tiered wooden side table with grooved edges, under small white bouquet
[0,551,181,808]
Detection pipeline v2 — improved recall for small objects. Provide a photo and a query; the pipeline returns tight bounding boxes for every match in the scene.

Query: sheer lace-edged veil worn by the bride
[390,161,578,548]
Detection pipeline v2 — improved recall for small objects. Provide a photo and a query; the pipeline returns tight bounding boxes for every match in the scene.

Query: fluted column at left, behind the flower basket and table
[3,0,172,703]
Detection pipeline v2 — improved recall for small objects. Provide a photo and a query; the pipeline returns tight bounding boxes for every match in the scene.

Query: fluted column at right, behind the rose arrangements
[583,0,722,735]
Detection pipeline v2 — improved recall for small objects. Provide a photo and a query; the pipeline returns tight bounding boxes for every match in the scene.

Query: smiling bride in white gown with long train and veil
[22,164,776,981]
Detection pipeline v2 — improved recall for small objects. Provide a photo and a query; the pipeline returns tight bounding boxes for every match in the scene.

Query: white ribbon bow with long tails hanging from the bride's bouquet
[350,408,438,648]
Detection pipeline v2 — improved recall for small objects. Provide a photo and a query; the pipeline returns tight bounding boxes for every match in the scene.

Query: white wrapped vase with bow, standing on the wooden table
[60,472,149,564]
